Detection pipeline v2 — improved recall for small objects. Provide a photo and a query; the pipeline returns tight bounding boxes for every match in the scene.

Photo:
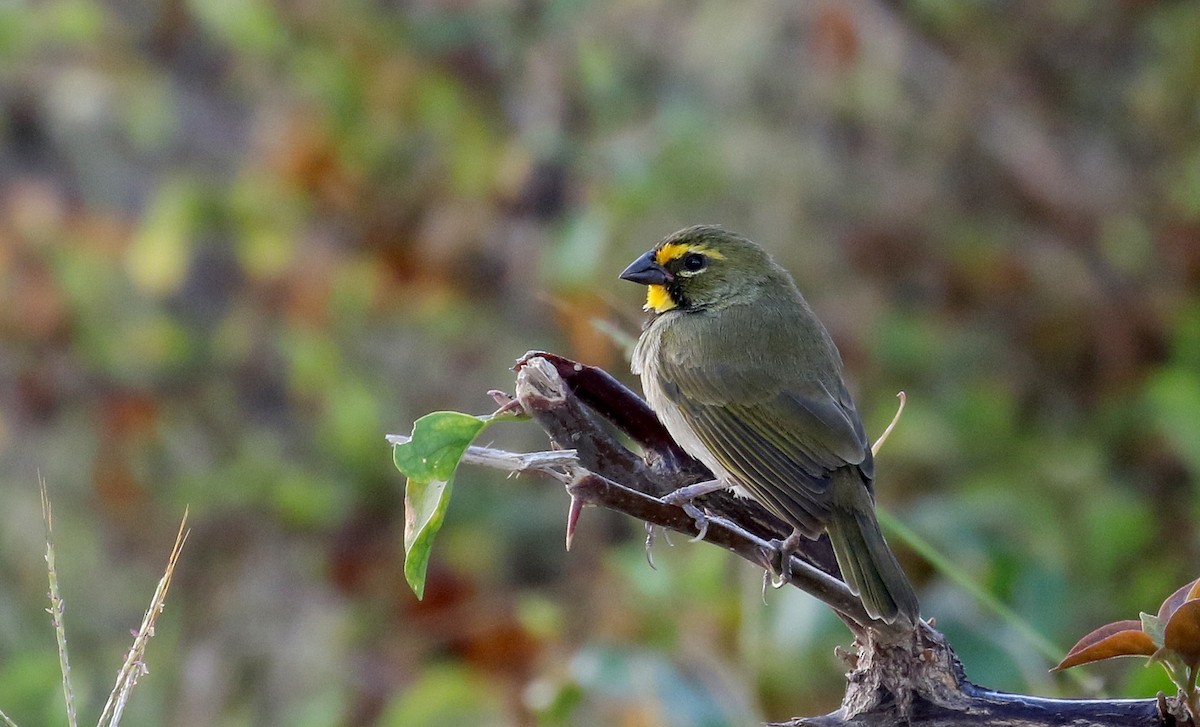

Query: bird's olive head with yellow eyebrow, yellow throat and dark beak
[620,224,788,313]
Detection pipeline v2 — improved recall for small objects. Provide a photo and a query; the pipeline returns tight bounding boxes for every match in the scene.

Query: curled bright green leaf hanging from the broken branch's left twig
[392,411,493,599]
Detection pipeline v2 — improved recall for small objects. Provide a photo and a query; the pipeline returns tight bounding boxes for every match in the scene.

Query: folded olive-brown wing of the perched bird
[660,356,872,530]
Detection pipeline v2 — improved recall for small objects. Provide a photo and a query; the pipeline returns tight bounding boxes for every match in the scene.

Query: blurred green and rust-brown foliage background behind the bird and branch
[0,0,1200,727]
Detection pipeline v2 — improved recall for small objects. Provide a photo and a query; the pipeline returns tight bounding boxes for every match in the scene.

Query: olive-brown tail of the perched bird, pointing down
[827,485,920,624]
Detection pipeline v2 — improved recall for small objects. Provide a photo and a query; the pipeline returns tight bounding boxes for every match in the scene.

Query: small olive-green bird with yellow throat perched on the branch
[620,226,919,624]
